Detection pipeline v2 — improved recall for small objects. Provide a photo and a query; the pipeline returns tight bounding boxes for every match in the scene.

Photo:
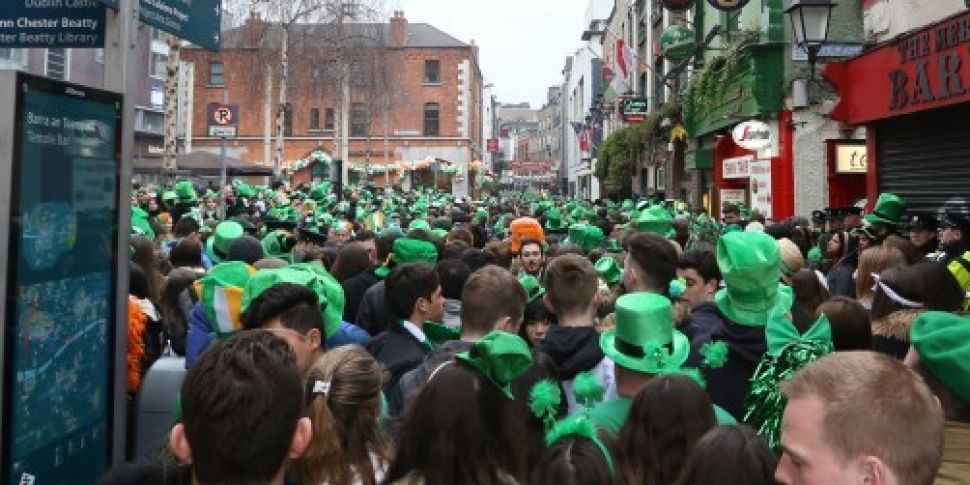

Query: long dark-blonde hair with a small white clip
[296,345,393,484]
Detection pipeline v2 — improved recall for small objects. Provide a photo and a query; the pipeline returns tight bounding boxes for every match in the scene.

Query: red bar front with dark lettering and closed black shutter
[823,11,970,211]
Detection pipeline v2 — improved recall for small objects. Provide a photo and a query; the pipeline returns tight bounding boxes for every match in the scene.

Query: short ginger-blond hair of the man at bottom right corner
[781,351,944,485]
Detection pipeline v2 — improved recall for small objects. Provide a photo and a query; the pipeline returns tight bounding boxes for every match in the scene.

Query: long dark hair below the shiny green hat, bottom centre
[385,362,526,485]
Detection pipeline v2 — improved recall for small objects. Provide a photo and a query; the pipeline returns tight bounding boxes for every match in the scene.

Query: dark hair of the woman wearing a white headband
[870,261,965,320]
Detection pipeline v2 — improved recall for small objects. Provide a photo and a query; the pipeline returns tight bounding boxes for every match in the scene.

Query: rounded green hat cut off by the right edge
[909,312,970,403]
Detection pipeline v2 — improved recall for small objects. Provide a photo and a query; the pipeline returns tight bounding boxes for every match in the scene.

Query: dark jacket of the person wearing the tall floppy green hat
[687,312,768,421]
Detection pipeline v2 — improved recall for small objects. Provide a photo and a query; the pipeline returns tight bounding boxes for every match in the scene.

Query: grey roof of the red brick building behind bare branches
[215,22,470,49]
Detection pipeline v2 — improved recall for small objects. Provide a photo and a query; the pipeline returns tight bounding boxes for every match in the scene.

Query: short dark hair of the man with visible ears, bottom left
[180,332,303,484]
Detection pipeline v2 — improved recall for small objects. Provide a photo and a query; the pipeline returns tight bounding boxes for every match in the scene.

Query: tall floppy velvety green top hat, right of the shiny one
[714,231,793,327]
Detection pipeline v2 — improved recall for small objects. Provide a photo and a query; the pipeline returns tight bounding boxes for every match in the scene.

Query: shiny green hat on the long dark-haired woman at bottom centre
[455,331,532,399]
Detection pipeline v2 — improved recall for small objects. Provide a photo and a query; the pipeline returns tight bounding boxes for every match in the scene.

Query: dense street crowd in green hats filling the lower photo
[102,181,970,485]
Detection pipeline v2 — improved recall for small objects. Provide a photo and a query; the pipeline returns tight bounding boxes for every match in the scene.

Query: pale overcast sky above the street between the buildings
[387,0,588,108]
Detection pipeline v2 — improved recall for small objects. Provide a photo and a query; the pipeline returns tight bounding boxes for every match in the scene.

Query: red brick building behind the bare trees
[182,12,484,195]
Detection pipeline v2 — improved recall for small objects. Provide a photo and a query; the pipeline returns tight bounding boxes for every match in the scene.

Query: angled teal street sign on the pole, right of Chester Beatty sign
[99,0,222,51]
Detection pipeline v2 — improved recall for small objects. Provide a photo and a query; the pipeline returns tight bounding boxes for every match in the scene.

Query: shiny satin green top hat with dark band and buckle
[600,292,690,374]
